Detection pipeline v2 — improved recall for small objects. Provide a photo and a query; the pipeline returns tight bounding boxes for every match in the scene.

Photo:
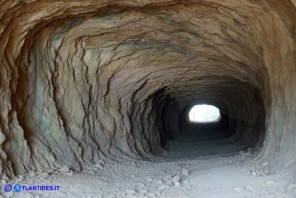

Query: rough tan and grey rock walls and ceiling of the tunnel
[0,0,296,177]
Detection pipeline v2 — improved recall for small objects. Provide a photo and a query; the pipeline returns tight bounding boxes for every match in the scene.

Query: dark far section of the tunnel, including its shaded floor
[152,82,266,160]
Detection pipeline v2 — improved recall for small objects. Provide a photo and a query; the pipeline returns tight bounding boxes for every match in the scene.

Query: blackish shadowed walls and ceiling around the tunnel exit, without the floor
[153,80,265,148]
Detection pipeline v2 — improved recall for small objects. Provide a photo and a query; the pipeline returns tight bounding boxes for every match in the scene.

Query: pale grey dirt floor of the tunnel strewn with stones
[1,131,296,198]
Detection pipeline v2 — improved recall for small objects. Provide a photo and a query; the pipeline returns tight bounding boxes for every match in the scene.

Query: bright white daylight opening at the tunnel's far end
[189,104,221,122]
